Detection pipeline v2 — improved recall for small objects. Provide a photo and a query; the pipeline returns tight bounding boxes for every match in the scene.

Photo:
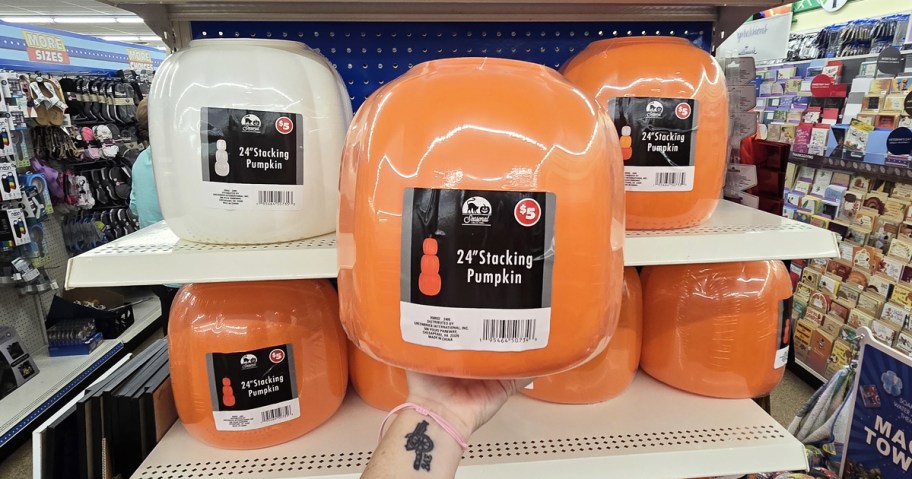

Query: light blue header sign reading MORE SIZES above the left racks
[0,22,167,73]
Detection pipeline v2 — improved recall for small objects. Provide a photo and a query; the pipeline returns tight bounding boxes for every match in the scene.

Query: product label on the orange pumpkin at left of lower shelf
[206,344,301,431]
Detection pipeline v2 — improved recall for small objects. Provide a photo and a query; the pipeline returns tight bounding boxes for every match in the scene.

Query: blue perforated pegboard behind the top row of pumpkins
[192,22,712,109]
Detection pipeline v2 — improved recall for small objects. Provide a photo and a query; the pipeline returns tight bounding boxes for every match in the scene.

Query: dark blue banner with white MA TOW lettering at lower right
[842,339,912,479]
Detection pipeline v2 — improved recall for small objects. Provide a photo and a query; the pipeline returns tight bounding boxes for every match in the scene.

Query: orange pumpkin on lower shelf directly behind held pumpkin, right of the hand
[522,268,643,404]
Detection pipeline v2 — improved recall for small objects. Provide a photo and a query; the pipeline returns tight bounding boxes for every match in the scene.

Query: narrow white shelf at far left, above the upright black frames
[0,300,161,447]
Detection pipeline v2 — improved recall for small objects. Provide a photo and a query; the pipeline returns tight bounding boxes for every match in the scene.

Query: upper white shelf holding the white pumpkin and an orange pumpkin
[66,201,839,288]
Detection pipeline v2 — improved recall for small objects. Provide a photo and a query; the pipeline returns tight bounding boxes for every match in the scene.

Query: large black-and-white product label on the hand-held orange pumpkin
[400,188,557,351]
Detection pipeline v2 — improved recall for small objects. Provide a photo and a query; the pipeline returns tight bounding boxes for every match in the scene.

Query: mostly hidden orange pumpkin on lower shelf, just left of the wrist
[348,344,408,411]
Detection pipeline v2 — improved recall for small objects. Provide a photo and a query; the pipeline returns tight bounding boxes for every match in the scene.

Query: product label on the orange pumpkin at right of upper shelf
[608,97,698,191]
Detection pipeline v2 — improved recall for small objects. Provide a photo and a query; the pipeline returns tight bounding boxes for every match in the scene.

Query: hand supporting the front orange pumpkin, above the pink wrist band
[406,371,532,438]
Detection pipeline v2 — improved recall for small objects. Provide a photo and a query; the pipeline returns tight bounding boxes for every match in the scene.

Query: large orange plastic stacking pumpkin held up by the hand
[337,58,624,378]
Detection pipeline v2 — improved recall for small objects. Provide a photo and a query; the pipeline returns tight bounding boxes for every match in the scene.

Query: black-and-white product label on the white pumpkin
[201,108,304,210]
